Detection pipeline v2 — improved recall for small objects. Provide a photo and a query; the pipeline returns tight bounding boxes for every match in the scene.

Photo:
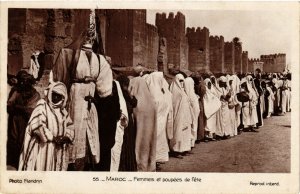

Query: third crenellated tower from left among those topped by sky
[209,36,224,73]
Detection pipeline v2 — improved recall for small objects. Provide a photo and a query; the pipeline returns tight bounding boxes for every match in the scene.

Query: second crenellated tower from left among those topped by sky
[187,27,210,72]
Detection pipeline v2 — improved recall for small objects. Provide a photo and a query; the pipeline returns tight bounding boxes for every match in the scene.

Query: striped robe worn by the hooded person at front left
[19,99,74,171]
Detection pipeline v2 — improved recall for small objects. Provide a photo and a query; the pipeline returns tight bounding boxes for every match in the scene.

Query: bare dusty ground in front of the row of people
[161,113,291,173]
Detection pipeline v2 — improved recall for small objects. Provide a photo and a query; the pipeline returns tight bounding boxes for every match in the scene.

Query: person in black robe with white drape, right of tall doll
[94,81,128,171]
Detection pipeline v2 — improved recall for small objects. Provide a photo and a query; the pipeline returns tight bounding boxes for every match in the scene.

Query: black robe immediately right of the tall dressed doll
[95,82,121,171]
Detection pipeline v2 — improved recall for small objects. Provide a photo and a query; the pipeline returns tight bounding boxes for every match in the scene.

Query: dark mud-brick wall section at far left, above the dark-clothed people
[7,9,47,74]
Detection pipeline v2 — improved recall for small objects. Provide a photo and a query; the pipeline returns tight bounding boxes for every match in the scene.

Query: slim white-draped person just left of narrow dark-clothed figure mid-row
[184,77,200,148]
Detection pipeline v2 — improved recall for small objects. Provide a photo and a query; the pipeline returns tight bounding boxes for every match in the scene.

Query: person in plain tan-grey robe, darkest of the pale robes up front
[129,77,157,172]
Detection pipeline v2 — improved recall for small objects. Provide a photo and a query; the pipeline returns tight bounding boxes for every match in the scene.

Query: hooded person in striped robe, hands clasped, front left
[19,82,75,171]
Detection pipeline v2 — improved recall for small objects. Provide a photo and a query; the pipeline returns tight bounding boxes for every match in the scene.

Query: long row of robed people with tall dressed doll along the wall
[7,9,291,171]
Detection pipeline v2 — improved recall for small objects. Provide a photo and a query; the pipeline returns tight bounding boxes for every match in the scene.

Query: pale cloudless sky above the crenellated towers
[147,10,295,63]
